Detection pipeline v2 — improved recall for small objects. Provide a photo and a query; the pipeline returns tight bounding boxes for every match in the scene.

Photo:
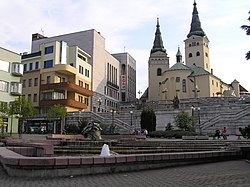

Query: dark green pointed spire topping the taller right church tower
[187,1,206,38]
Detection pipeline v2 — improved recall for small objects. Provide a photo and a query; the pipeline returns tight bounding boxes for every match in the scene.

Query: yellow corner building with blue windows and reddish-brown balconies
[22,41,93,114]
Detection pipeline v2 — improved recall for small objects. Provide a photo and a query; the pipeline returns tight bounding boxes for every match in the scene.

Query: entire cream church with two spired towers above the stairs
[147,2,240,101]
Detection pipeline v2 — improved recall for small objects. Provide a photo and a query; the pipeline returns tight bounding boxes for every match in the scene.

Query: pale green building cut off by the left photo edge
[0,47,23,133]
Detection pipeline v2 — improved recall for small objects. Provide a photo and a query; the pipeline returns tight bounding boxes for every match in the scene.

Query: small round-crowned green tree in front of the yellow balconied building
[47,104,67,134]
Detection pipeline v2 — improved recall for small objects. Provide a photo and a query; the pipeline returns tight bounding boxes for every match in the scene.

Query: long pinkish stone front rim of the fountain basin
[0,147,242,177]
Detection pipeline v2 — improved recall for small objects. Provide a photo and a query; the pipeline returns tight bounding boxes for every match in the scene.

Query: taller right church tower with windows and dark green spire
[184,1,211,73]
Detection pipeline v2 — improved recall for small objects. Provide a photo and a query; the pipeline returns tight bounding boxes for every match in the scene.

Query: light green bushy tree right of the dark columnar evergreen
[174,111,194,131]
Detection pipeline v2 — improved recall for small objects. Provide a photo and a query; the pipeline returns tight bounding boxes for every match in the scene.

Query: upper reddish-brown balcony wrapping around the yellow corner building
[40,82,93,97]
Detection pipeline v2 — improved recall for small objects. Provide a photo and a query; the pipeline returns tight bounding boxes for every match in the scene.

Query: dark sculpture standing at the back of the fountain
[82,122,102,140]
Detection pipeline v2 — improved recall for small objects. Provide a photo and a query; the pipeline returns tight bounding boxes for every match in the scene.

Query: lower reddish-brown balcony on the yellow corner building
[39,99,87,110]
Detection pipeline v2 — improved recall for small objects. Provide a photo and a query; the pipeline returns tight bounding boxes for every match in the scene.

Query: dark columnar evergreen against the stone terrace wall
[141,108,156,132]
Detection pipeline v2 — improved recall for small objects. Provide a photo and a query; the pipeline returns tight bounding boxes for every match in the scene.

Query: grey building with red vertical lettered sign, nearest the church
[112,53,136,102]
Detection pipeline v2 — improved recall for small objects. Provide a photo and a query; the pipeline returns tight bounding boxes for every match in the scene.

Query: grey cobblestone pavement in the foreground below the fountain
[0,160,250,187]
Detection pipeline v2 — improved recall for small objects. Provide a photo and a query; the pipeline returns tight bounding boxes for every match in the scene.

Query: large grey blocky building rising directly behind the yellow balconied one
[31,29,133,112]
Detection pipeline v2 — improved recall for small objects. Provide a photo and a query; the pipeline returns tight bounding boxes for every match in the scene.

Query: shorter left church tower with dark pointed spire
[148,18,169,101]
